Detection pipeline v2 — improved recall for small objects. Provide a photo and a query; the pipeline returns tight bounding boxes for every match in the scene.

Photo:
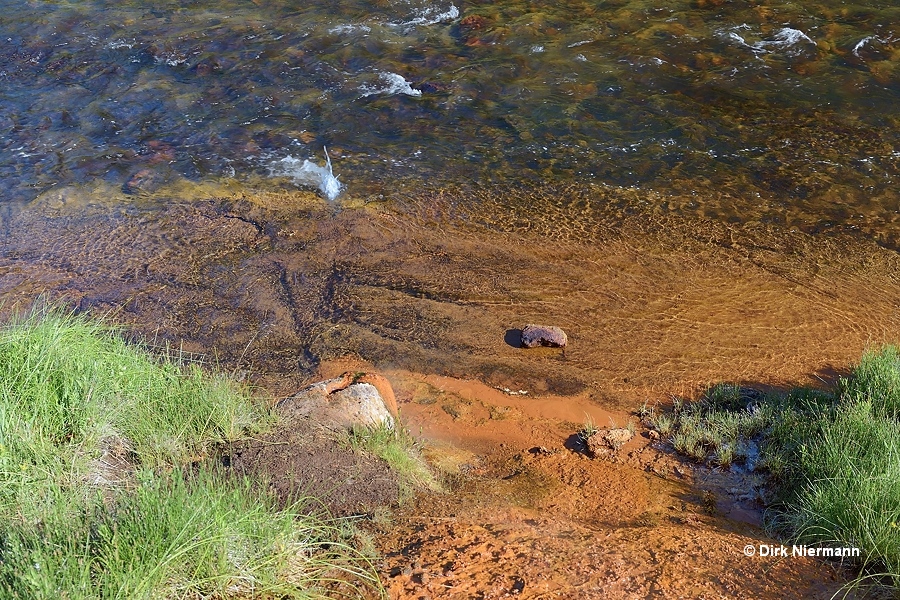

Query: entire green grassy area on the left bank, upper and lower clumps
[0,310,379,599]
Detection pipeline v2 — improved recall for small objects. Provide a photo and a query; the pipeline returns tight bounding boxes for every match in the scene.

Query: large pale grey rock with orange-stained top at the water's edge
[277,376,394,430]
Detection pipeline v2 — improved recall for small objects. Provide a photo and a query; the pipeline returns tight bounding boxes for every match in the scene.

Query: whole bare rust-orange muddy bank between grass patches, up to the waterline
[348,371,855,599]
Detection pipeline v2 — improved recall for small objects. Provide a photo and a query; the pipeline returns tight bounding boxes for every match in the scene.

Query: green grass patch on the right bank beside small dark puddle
[656,346,900,592]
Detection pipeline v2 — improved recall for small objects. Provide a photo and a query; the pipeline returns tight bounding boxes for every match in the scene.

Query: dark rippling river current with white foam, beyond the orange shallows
[0,0,900,239]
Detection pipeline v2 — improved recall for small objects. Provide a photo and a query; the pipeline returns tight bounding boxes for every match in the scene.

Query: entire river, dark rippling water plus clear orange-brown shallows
[0,0,900,397]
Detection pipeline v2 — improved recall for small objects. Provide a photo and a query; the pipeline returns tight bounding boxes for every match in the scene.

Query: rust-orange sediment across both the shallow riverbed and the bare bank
[0,183,900,598]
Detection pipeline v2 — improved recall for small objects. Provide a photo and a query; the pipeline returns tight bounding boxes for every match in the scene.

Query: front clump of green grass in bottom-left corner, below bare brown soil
[0,470,377,600]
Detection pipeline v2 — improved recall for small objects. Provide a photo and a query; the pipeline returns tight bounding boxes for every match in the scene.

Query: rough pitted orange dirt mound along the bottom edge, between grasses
[374,499,852,599]
